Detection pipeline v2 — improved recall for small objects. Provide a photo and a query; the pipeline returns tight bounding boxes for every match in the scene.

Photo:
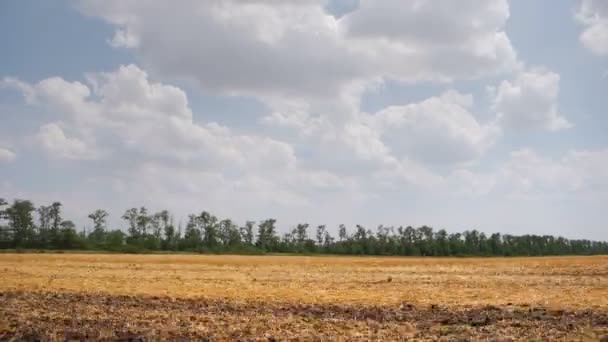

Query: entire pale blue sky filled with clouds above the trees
[0,0,608,240]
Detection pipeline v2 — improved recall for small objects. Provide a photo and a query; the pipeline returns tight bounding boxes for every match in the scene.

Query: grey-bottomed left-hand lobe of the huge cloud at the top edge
[76,1,362,101]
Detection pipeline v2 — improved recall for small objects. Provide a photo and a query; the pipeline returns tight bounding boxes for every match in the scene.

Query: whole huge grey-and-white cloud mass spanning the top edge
[79,0,518,99]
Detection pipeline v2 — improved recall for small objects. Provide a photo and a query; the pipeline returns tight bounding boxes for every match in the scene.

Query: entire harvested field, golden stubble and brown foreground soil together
[0,254,608,341]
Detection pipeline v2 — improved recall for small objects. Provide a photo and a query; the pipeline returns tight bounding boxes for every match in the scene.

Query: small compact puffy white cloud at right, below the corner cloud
[490,69,572,131]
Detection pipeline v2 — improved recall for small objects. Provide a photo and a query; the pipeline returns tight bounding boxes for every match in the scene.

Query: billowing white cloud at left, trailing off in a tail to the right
[4,65,295,175]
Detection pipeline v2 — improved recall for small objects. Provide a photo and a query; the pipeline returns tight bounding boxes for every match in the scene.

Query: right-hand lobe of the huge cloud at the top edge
[339,0,519,80]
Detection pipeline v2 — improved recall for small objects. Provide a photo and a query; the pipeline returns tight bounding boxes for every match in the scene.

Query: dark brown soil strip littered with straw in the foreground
[0,291,608,341]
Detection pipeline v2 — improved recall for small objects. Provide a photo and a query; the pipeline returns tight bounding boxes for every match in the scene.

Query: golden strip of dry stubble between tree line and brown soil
[0,254,608,310]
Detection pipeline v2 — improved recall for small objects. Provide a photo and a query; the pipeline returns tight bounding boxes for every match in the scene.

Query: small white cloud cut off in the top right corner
[576,0,608,55]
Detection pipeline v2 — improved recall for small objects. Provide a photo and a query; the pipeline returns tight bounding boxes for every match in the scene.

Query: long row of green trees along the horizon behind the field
[0,198,608,256]
